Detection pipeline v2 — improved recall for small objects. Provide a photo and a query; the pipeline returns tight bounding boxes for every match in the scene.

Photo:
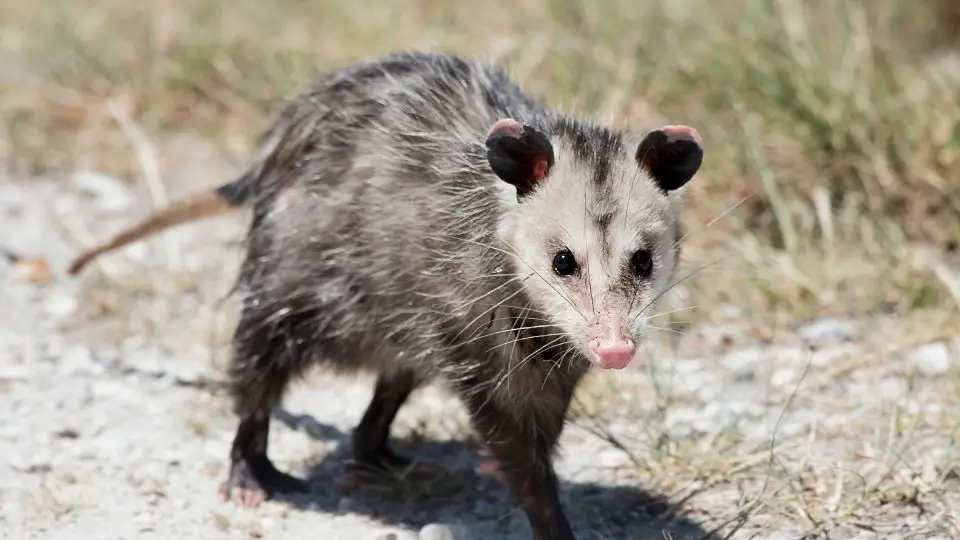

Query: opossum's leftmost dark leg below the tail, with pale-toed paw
[220,309,308,507]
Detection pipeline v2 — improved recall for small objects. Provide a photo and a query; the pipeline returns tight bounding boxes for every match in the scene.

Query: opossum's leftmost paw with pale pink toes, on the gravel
[219,457,310,508]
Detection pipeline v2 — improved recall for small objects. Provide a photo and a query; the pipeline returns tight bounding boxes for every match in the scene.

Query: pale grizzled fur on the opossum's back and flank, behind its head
[240,53,546,326]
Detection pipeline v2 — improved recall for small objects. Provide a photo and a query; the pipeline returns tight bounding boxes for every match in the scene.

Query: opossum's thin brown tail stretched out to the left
[67,173,252,275]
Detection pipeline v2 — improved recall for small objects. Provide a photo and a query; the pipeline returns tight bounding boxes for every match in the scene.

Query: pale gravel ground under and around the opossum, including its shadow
[0,163,960,540]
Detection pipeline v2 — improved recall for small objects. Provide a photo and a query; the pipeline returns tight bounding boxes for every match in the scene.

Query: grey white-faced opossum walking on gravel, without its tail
[75,52,703,540]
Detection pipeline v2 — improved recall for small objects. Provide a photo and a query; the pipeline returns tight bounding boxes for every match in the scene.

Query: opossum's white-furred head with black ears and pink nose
[487,119,703,369]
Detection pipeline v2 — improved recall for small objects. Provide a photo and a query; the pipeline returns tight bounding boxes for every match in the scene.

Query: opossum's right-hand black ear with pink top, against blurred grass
[637,126,703,191]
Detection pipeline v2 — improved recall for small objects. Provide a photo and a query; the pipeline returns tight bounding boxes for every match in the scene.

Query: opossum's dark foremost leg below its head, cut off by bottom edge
[463,383,575,540]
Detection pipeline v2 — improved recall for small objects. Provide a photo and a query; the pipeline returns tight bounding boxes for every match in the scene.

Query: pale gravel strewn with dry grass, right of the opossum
[571,310,960,539]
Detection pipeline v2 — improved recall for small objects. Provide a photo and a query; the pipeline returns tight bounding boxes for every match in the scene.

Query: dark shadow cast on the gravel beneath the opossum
[276,410,720,540]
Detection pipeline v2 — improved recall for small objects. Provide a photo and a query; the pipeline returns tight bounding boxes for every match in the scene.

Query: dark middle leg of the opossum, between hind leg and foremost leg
[340,370,450,491]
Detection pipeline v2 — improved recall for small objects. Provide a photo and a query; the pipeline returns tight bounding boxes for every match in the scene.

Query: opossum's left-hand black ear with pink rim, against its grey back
[487,118,554,198]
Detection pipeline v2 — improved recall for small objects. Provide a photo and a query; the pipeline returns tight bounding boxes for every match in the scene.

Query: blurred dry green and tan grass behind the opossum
[0,0,960,330]
